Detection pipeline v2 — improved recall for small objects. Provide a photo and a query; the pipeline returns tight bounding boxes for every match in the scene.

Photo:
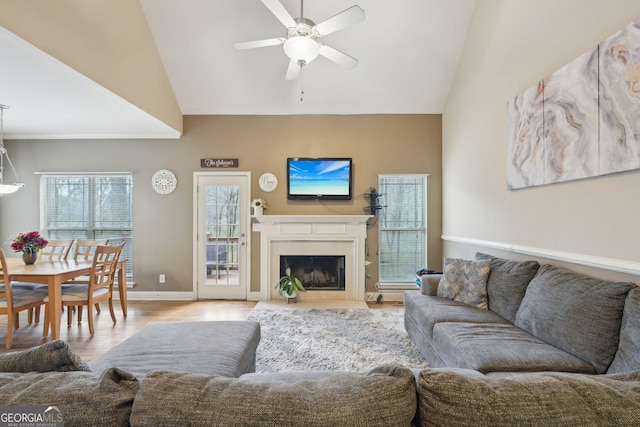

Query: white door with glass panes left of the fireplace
[194,172,251,300]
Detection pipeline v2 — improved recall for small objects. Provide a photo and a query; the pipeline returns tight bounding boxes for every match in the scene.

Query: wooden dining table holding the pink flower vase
[6,258,127,340]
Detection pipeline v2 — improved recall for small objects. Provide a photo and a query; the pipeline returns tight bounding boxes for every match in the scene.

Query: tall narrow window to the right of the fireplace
[378,175,428,284]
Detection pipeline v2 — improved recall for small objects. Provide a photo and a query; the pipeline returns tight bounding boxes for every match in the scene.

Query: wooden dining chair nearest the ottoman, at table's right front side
[43,243,124,336]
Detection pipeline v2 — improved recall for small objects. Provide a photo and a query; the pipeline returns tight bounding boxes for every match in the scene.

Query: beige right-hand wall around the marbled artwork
[443,0,640,281]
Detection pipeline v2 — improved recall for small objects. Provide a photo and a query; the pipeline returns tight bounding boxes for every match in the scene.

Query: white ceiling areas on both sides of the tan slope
[0,0,476,139]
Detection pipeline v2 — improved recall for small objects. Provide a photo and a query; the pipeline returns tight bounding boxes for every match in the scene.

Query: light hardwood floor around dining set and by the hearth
[0,300,402,362]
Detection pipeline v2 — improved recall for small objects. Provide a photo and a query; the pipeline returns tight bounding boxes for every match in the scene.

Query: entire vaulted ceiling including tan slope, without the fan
[0,0,475,139]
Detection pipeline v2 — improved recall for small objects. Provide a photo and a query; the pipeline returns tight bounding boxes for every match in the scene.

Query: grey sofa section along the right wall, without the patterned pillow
[404,253,640,374]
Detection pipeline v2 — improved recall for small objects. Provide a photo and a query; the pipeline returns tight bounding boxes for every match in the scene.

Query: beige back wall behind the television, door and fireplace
[0,115,442,298]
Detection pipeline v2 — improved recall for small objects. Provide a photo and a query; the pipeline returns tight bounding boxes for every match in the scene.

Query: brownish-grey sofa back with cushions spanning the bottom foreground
[0,336,640,427]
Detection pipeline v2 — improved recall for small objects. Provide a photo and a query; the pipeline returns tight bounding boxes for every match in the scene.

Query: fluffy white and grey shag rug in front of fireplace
[248,304,427,372]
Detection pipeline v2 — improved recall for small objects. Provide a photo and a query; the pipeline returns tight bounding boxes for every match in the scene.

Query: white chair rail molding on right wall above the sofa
[440,234,640,276]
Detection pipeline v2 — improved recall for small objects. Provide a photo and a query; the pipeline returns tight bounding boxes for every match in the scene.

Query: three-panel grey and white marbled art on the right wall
[507,20,640,190]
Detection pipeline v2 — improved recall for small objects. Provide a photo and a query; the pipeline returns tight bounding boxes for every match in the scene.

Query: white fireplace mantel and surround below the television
[253,215,372,301]
